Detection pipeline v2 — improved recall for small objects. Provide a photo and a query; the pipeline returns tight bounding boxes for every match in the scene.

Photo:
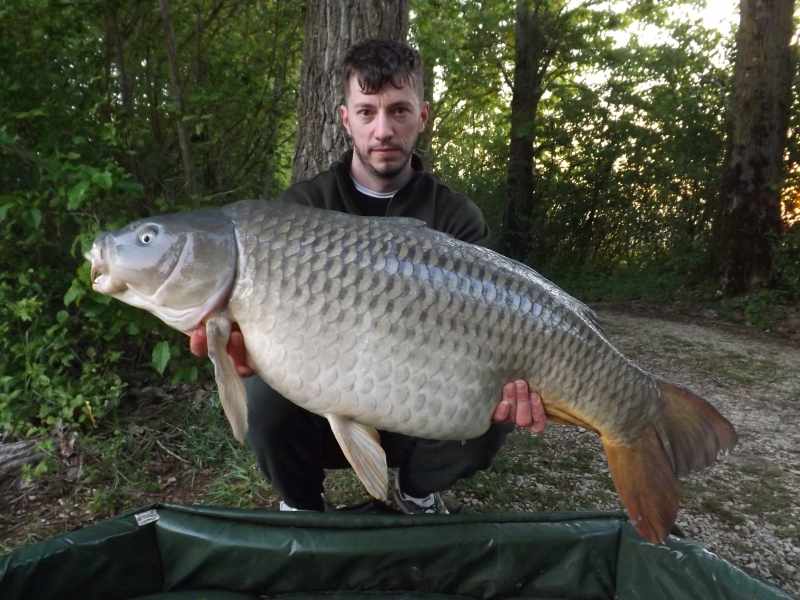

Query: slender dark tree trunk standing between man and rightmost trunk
[501,2,555,261]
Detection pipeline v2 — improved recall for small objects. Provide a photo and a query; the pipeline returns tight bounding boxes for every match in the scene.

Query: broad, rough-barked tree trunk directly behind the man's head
[290,0,408,182]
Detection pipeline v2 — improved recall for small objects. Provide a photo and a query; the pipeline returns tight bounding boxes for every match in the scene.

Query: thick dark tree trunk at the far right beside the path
[712,0,794,295]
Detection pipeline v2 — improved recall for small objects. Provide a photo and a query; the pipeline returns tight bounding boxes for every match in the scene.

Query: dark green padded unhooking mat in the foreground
[0,504,790,600]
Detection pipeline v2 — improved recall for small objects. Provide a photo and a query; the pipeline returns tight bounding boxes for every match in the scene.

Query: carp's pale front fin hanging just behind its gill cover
[206,315,247,443]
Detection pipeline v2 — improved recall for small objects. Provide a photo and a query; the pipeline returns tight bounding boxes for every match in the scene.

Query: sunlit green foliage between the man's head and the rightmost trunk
[411,0,730,300]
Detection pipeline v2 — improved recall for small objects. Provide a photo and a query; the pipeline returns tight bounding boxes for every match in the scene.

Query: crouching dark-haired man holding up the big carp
[190,40,546,514]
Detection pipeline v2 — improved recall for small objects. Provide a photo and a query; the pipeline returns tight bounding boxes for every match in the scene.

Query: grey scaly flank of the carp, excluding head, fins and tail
[226,204,653,439]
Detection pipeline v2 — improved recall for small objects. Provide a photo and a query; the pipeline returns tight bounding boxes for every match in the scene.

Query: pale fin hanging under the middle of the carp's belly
[325,414,389,500]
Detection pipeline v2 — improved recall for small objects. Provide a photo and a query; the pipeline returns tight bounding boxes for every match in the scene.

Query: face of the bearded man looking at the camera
[339,77,428,181]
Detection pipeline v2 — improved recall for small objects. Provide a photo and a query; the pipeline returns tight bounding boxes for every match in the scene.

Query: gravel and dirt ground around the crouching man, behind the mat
[0,305,800,597]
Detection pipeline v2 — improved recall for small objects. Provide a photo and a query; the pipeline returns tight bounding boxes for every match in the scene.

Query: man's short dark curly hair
[342,39,423,103]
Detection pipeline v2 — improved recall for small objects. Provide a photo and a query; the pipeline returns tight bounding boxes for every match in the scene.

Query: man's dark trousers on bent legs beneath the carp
[244,376,511,511]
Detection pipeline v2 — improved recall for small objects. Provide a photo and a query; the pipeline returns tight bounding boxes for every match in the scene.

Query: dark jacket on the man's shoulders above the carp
[278,150,489,246]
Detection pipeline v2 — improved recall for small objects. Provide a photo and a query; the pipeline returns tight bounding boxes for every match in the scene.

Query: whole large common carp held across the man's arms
[86,200,737,542]
